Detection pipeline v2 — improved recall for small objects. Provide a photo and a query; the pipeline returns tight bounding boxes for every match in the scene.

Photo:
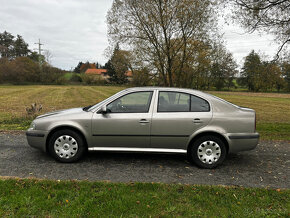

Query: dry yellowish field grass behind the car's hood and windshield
[0,86,123,117]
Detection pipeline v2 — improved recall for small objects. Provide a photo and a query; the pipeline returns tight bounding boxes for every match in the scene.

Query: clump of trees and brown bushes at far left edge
[0,31,65,84]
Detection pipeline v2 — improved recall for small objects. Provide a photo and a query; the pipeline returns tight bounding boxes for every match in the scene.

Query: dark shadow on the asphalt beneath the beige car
[29,150,256,168]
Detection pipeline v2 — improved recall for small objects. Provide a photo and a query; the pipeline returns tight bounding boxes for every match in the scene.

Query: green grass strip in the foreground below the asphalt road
[0,179,290,217]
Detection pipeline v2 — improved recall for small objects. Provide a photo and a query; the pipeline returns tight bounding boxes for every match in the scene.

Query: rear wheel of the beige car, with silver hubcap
[187,135,227,169]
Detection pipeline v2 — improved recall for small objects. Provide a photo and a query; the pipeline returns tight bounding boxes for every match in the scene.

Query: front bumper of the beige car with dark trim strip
[26,129,48,151]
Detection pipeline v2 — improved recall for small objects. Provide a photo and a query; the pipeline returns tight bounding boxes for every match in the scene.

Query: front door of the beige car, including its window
[92,91,154,148]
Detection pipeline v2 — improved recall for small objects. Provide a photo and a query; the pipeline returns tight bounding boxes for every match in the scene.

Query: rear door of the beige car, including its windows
[151,91,212,149]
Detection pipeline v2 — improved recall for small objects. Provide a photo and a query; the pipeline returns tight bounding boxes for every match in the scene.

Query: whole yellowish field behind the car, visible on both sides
[0,85,290,140]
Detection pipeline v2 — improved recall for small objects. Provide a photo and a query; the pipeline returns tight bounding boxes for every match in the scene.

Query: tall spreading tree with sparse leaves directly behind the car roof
[107,0,215,86]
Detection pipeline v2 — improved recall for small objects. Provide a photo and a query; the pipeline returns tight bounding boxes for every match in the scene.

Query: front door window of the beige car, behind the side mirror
[107,92,152,113]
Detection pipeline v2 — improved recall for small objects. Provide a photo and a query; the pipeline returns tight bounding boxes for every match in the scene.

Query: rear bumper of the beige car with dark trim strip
[227,132,260,153]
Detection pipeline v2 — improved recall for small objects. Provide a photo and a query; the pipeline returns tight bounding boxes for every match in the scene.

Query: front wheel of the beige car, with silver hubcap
[48,129,86,163]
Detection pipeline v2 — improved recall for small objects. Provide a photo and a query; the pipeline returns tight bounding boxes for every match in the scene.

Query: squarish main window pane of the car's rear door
[158,92,190,112]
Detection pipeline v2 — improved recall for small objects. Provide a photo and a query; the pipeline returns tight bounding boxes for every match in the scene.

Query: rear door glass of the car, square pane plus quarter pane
[157,92,210,112]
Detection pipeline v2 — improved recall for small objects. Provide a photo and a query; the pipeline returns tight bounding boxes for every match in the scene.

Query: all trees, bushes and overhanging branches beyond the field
[0,0,290,91]
